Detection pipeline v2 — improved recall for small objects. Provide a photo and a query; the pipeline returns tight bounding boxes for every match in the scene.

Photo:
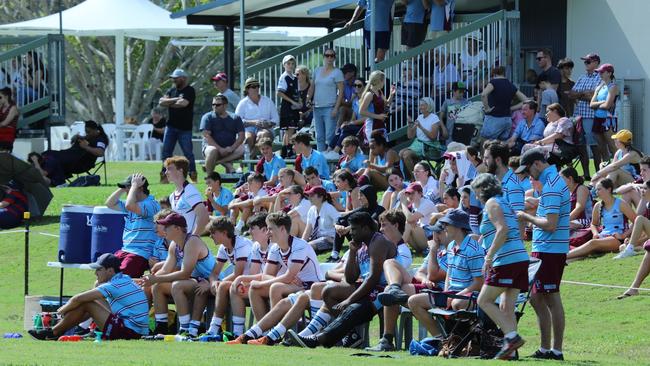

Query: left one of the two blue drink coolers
[58,205,94,263]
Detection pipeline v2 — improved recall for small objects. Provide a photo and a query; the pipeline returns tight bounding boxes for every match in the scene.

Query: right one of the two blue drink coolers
[90,206,126,262]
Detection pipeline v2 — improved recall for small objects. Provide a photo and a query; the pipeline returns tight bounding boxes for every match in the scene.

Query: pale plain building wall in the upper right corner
[566,0,650,152]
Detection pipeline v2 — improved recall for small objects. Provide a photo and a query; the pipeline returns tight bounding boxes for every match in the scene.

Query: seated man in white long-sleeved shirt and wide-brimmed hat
[235,77,280,156]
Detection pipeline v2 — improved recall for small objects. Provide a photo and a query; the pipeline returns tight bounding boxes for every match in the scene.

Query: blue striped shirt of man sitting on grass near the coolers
[97,272,149,335]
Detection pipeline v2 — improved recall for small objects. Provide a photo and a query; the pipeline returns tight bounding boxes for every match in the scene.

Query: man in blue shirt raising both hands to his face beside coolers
[106,173,160,278]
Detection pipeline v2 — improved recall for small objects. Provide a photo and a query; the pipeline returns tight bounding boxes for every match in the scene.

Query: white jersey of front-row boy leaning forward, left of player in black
[268,236,325,283]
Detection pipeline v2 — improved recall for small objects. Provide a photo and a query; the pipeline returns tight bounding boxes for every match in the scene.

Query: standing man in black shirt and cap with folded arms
[158,69,197,183]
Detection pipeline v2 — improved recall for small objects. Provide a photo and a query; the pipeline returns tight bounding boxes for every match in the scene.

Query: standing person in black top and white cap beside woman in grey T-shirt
[277,55,302,158]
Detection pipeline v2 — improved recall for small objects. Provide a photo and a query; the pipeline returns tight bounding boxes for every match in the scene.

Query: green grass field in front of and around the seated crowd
[0,163,650,365]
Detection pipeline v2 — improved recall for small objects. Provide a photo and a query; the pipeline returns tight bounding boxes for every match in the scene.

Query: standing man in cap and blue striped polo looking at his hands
[515,149,571,360]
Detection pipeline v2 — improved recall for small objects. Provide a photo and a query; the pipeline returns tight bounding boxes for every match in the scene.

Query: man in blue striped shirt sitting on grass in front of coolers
[29,253,149,341]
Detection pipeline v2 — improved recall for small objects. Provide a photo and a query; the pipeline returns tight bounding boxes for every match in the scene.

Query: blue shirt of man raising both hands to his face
[117,196,160,259]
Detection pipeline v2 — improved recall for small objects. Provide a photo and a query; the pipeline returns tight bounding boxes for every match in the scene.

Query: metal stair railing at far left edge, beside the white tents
[0,35,65,128]
